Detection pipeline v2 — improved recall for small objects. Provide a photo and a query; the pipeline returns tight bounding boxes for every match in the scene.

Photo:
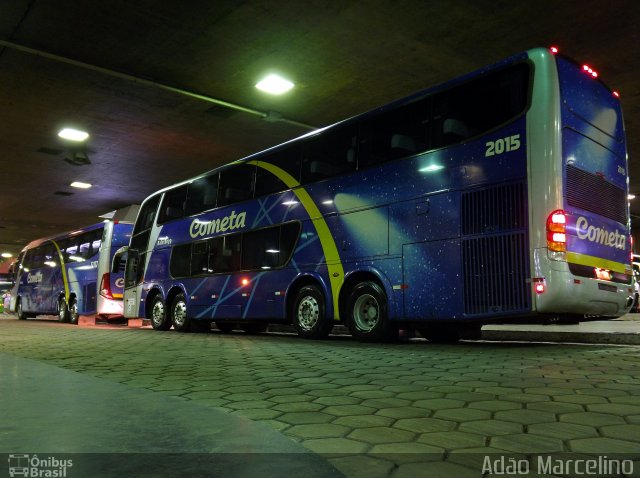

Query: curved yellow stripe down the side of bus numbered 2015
[248,161,344,320]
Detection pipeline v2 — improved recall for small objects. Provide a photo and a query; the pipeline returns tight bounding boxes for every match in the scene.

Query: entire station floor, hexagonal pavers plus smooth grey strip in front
[0,314,640,478]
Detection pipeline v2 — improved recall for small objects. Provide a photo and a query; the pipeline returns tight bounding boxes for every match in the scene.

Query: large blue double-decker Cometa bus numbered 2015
[117,48,633,341]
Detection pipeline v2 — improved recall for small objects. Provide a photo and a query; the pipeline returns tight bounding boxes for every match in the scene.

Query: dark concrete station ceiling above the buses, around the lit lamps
[0,0,640,262]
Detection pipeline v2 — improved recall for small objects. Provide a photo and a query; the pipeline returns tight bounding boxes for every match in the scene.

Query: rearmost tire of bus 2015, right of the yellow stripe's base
[346,281,398,342]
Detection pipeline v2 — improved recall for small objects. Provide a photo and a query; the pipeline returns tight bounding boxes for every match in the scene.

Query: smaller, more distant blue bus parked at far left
[11,221,133,324]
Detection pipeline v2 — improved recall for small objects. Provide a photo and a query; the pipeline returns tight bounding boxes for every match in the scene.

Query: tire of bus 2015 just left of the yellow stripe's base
[292,285,333,339]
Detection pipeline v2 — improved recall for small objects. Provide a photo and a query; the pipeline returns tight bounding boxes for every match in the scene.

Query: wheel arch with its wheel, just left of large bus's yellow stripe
[286,276,334,339]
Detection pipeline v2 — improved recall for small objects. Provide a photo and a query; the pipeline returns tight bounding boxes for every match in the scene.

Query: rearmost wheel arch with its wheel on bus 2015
[340,272,398,342]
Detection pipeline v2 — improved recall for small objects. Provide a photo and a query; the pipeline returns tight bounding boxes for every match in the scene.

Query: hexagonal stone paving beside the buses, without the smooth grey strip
[0,319,640,478]
